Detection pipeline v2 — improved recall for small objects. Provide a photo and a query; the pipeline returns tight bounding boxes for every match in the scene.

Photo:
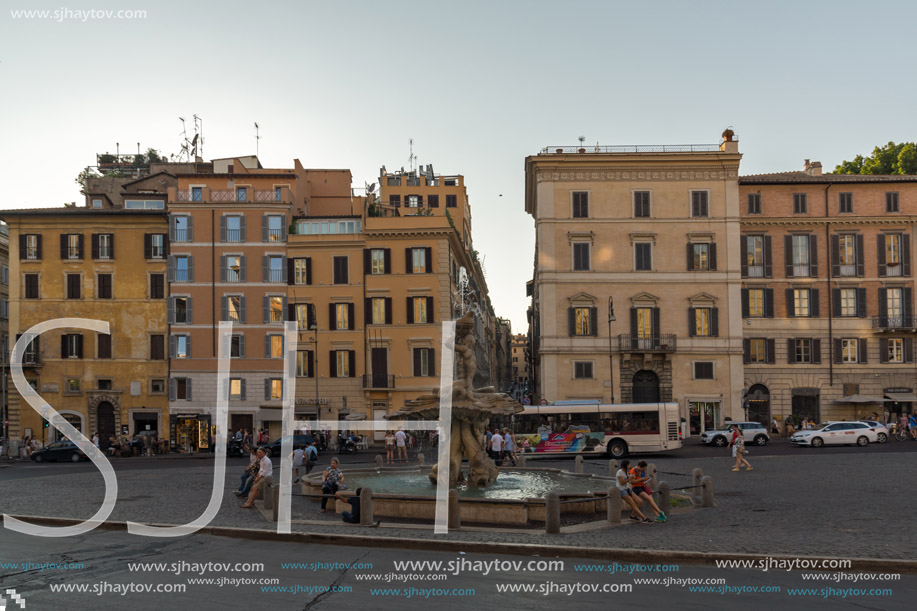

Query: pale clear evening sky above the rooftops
[0,0,917,333]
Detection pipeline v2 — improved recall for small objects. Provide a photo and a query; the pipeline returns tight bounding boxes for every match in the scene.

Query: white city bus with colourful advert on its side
[493,401,681,458]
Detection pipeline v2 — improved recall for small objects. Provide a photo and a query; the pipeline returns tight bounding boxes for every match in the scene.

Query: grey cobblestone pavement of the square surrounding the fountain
[0,448,917,558]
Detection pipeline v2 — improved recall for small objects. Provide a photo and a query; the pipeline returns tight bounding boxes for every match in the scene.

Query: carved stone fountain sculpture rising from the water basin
[385,312,523,488]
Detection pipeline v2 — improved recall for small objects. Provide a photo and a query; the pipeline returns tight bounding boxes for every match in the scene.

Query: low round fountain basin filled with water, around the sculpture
[302,467,615,526]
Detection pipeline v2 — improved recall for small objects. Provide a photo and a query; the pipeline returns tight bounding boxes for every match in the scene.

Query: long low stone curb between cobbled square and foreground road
[11,515,917,574]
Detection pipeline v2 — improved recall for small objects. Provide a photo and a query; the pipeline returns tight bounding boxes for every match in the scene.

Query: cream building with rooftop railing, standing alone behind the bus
[525,130,743,434]
